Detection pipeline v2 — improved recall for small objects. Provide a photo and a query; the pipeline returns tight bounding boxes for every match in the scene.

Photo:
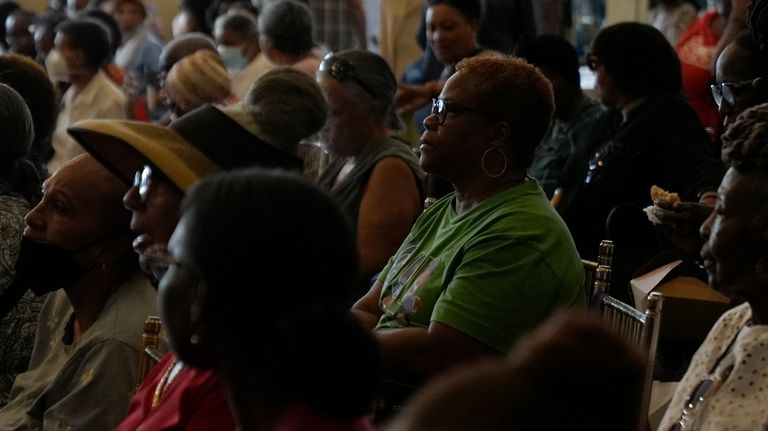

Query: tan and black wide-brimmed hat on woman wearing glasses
[67,105,302,192]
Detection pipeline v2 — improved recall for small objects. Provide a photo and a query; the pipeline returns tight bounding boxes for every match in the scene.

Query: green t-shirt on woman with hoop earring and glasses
[376,181,586,352]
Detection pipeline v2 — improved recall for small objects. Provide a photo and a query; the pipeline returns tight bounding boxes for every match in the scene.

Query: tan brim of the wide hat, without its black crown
[67,120,221,193]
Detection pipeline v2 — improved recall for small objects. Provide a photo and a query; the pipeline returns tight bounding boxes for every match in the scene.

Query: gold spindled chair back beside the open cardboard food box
[599,292,664,430]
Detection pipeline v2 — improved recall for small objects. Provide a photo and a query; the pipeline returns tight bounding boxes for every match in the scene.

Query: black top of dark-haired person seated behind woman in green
[559,95,725,257]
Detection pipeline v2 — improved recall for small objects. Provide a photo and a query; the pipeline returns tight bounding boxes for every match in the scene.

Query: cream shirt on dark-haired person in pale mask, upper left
[48,71,128,173]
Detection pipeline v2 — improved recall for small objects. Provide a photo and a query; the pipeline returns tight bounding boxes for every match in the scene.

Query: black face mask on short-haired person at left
[14,237,94,296]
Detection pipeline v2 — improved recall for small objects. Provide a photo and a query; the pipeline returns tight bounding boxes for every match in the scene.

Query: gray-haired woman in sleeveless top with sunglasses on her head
[318,50,423,296]
